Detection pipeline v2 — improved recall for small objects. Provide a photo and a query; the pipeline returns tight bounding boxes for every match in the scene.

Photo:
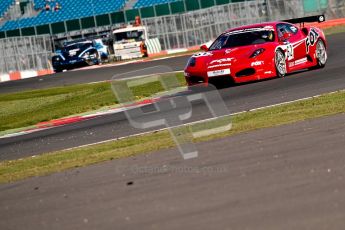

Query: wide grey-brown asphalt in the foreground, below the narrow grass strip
[0,114,345,230]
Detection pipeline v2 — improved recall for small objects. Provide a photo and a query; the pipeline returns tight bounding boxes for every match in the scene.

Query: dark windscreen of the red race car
[209,29,274,51]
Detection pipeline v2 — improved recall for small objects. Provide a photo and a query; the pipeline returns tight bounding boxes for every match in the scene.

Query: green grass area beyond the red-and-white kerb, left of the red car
[0,73,185,132]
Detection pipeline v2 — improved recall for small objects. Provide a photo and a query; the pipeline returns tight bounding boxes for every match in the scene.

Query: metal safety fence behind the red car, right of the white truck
[143,0,345,50]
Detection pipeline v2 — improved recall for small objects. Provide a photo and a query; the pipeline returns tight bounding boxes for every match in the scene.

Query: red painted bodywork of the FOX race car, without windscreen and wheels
[185,22,326,86]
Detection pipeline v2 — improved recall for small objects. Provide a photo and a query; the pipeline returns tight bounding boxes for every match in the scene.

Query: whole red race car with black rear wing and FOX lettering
[185,15,327,86]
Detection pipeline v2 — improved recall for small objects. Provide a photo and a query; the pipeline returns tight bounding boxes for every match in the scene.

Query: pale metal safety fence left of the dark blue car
[0,36,52,74]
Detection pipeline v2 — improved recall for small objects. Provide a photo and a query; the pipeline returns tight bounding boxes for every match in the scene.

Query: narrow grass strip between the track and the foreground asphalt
[0,91,345,183]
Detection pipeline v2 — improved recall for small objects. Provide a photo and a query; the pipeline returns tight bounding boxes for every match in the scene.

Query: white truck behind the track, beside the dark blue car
[113,25,148,60]
